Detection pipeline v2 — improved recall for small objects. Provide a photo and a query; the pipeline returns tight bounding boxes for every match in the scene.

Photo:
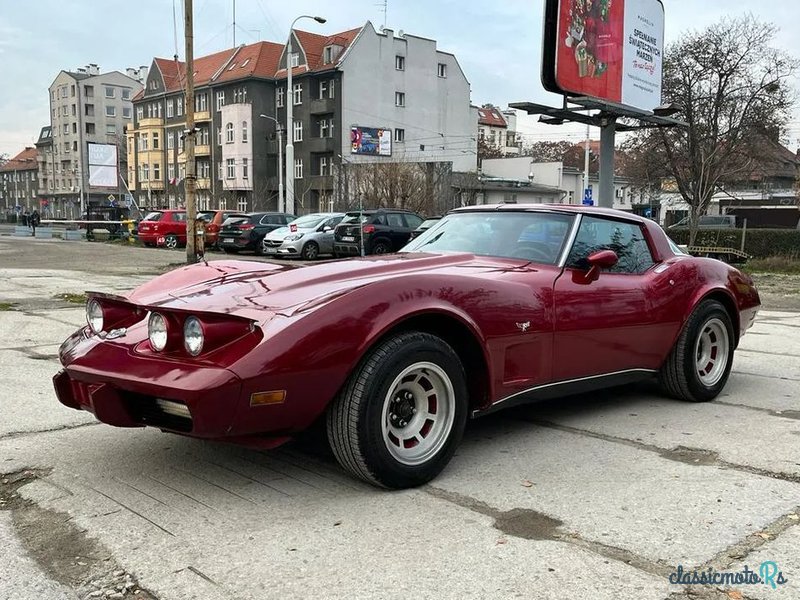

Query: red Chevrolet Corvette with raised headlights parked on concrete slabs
[54,205,760,488]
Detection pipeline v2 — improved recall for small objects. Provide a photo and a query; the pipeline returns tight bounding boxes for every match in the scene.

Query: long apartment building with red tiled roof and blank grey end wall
[126,22,477,213]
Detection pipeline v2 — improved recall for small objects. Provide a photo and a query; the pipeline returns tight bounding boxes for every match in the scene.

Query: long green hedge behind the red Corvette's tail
[667,229,800,258]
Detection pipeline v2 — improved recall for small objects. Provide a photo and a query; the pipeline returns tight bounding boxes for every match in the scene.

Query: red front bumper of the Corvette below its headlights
[53,330,242,438]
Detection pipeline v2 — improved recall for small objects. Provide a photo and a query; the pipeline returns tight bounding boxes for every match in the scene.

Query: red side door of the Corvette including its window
[553,215,662,381]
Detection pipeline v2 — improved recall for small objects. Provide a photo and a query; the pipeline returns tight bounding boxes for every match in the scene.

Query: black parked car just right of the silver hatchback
[333,208,425,258]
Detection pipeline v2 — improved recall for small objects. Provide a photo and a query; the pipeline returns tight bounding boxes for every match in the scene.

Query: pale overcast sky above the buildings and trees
[0,0,800,155]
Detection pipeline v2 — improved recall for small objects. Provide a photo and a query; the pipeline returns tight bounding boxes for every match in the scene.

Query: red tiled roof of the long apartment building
[145,27,362,95]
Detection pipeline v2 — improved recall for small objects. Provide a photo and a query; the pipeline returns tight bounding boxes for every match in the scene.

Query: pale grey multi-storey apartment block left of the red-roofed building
[48,64,147,216]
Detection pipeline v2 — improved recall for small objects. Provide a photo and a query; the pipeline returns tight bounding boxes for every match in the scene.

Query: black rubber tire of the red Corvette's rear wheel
[659,300,736,402]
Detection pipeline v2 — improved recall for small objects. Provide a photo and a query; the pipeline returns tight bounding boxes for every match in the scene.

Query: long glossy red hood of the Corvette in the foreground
[128,253,535,322]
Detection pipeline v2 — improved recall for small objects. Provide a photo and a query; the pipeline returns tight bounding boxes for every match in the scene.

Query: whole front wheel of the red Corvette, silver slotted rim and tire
[327,332,468,489]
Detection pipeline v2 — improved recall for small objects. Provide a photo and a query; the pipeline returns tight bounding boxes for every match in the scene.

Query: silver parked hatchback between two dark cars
[263,213,344,260]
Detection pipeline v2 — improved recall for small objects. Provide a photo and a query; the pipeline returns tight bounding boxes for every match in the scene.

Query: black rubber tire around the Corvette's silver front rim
[327,332,468,489]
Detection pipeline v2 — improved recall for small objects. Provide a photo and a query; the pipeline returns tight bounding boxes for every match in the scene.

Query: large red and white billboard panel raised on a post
[542,0,664,111]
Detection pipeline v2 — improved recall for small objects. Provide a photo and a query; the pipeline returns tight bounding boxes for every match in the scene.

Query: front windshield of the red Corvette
[403,211,574,264]
